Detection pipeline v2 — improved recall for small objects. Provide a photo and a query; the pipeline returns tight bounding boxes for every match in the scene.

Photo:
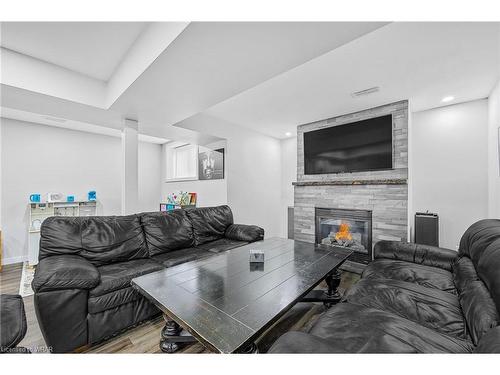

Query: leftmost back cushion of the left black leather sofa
[39,215,149,266]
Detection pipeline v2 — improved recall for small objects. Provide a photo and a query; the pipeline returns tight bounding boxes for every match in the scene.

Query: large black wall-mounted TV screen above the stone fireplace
[304,115,392,174]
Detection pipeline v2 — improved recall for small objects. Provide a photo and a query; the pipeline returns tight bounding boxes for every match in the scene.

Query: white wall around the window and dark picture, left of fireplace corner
[179,114,284,238]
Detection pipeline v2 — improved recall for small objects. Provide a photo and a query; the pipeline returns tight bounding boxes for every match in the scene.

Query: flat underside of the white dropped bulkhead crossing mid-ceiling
[110,22,386,125]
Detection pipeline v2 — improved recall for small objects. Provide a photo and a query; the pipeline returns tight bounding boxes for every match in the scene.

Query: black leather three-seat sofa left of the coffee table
[32,206,264,352]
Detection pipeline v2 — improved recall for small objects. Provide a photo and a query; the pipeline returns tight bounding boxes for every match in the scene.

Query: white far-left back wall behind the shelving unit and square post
[1,118,161,263]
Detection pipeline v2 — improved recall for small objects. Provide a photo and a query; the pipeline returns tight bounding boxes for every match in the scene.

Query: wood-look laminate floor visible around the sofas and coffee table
[0,264,359,353]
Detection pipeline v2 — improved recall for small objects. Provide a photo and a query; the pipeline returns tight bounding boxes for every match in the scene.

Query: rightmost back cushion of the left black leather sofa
[186,206,233,246]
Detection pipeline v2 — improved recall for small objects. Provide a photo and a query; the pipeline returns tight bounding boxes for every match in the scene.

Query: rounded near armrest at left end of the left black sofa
[31,255,101,292]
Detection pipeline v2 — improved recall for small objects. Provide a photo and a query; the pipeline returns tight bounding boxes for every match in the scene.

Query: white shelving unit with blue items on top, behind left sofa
[28,201,97,266]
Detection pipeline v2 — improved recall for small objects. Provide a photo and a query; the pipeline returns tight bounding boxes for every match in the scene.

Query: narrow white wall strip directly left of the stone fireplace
[281,137,297,238]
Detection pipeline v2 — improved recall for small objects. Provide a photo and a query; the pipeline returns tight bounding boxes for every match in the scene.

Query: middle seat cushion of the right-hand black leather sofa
[344,278,467,339]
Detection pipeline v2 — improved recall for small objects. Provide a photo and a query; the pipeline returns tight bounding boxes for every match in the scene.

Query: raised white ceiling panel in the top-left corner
[1,22,147,81]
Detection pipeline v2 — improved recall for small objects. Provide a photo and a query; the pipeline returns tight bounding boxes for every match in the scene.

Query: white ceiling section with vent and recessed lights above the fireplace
[202,23,500,138]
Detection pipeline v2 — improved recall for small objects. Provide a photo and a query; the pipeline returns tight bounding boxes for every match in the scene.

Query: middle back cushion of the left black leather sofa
[140,210,194,256]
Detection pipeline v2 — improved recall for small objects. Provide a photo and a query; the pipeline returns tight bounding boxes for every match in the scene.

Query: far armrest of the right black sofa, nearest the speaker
[373,241,458,271]
